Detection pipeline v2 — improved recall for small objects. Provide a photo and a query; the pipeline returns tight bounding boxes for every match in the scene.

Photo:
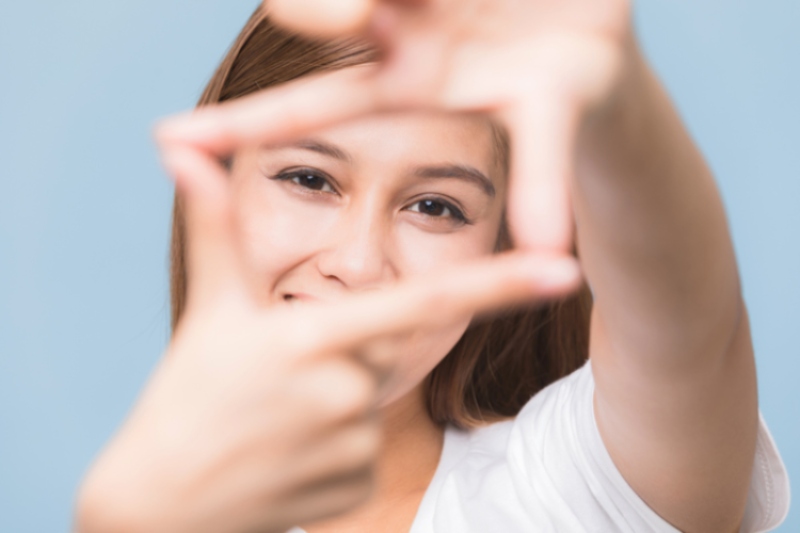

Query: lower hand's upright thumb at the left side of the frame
[162,144,245,305]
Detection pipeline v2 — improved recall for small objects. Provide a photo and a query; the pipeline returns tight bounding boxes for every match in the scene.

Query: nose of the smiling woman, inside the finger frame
[318,206,396,290]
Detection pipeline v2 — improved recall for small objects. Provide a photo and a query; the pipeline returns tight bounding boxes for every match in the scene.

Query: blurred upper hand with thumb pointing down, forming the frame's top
[158,0,635,253]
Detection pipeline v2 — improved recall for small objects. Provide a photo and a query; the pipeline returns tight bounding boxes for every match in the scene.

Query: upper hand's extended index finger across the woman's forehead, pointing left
[156,65,381,156]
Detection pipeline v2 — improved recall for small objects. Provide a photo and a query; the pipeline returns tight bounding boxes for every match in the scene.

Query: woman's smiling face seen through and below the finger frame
[232,114,505,405]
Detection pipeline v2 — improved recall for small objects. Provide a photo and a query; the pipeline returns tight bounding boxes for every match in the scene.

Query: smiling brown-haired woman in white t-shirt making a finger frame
[79,1,788,533]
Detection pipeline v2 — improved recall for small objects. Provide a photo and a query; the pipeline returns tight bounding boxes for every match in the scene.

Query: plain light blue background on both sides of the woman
[0,0,800,533]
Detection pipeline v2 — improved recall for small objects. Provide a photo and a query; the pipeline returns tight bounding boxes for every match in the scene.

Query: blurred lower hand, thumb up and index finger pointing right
[77,145,579,533]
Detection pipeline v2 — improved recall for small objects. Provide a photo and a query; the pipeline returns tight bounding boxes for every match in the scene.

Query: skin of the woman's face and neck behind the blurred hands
[233,114,505,533]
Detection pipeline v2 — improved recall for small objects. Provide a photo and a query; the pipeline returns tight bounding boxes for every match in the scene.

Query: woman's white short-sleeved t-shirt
[290,363,789,533]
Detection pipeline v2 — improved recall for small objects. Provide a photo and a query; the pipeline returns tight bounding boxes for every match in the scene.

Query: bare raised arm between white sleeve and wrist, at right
[573,39,758,531]
